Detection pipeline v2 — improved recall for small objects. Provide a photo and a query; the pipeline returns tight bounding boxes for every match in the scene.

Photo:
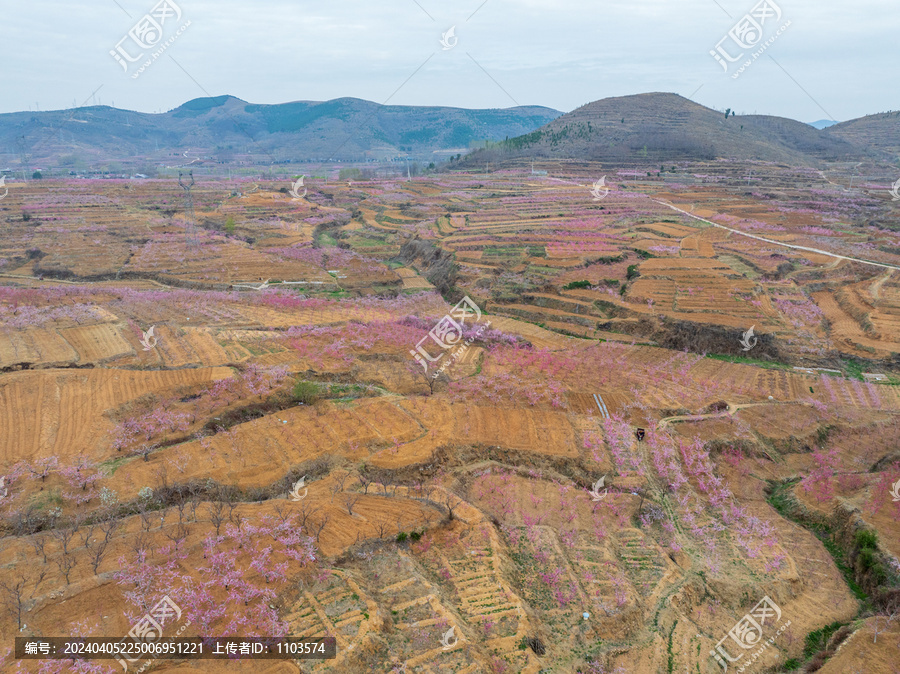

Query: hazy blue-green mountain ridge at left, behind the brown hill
[0,96,562,166]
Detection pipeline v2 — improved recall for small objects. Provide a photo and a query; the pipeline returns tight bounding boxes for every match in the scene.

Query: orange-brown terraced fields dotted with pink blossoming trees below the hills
[0,171,900,674]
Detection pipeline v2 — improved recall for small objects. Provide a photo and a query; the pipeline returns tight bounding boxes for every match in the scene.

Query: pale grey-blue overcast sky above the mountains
[0,0,900,122]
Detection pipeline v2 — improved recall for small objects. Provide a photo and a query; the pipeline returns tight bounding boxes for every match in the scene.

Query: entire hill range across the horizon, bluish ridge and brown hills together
[0,92,900,171]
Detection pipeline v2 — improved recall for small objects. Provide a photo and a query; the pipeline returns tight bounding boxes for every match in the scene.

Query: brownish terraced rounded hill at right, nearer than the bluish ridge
[467,93,900,165]
